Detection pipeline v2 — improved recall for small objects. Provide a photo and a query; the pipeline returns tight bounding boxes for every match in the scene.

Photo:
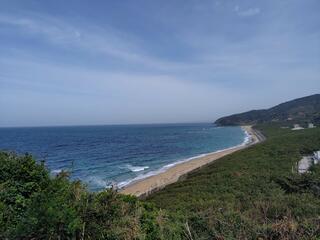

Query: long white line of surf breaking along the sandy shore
[116,128,252,189]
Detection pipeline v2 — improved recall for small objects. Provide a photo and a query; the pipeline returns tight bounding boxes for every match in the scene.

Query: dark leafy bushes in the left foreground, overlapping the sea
[0,153,178,239]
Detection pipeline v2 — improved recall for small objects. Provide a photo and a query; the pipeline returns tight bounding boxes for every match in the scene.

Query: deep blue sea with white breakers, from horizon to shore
[0,123,248,191]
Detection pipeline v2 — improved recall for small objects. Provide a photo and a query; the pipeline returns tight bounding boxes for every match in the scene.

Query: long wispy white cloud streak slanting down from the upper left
[0,14,198,71]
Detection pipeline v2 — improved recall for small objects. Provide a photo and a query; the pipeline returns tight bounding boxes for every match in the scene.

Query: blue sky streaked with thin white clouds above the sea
[0,0,320,127]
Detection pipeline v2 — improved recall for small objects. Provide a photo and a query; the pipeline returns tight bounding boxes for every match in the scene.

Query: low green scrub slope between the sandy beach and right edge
[147,125,320,239]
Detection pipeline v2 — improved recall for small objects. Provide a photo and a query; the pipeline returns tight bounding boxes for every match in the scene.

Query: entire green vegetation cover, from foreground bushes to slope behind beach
[0,125,320,240]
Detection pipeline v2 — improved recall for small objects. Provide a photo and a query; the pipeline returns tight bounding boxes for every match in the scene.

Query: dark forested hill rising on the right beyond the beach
[215,94,320,125]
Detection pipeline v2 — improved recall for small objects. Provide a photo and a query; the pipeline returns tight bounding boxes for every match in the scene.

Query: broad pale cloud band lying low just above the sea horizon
[0,55,245,126]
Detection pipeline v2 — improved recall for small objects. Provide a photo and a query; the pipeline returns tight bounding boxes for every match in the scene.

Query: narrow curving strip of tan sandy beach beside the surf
[120,126,263,197]
